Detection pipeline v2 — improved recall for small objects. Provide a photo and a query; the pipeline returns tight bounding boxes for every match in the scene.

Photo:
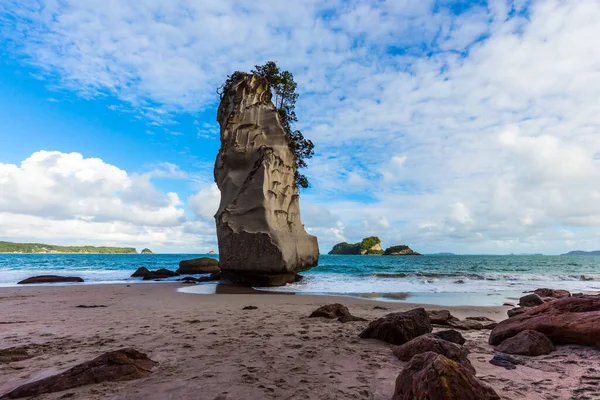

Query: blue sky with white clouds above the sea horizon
[0,0,600,253]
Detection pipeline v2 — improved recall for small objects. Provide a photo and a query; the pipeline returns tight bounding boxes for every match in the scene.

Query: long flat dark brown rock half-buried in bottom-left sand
[0,348,157,399]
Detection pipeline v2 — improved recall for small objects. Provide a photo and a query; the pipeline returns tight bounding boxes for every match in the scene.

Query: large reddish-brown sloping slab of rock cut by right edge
[489,296,600,348]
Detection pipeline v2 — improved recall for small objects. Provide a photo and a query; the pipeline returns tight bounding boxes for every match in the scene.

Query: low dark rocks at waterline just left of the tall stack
[131,257,221,283]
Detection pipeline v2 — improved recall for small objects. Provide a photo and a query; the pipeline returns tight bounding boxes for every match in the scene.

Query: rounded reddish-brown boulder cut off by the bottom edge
[392,352,500,400]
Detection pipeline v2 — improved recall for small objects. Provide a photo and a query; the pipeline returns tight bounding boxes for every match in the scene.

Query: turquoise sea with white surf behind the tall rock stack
[0,254,600,304]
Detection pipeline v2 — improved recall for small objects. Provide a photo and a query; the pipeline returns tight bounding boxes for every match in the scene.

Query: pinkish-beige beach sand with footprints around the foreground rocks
[0,283,600,400]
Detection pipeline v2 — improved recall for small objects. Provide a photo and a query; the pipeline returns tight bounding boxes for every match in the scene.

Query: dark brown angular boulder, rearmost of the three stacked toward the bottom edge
[360,308,432,344]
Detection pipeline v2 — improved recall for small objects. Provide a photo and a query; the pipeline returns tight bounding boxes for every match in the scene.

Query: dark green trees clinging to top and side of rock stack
[218,61,315,189]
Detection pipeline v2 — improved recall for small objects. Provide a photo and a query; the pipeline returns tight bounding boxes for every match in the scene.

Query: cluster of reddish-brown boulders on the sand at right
[311,289,600,400]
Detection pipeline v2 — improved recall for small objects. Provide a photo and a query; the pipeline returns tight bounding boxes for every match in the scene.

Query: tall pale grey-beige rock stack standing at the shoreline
[214,74,319,286]
